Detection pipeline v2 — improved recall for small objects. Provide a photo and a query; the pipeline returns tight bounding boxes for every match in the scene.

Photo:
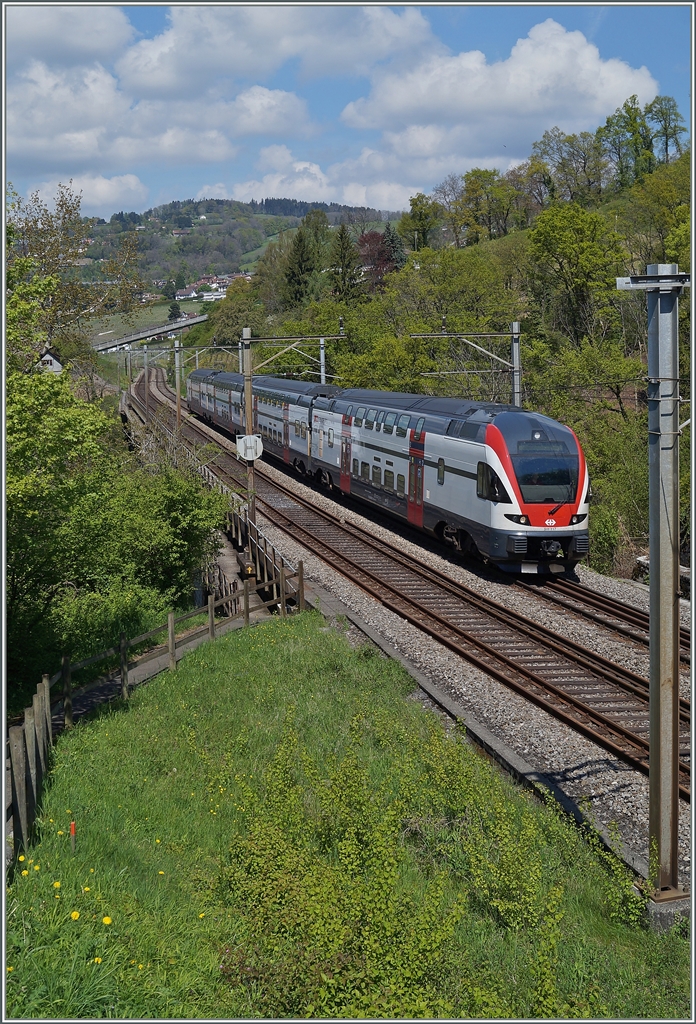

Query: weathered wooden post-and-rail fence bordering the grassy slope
[6,510,305,857]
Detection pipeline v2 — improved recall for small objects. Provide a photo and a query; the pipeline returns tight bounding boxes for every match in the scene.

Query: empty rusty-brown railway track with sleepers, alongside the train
[130,376,691,800]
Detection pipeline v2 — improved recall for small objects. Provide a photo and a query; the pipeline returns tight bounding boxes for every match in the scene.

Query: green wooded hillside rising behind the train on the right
[186,96,691,575]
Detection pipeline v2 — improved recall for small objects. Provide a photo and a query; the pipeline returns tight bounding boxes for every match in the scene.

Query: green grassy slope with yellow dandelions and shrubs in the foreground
[6,613,690,1019]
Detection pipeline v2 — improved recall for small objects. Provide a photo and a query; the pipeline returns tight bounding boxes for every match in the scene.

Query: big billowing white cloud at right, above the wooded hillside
[342,18,657,152]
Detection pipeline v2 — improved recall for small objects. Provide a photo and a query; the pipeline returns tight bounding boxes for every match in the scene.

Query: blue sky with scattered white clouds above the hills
[3,3,692,218]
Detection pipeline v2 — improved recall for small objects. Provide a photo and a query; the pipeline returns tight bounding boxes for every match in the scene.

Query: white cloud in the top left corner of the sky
[5,4,135,69]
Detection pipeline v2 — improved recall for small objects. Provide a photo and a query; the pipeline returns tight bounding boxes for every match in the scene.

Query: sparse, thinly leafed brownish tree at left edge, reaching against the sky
[7,182,144,370]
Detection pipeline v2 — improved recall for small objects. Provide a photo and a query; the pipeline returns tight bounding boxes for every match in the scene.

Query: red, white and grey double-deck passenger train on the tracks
[186,368,590,574]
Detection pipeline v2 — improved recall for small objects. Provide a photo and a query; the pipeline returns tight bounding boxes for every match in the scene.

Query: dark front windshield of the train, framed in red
[495,413,579,505]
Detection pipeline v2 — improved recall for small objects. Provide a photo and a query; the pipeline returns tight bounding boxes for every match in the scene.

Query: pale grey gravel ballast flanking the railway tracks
[249,465,691,887]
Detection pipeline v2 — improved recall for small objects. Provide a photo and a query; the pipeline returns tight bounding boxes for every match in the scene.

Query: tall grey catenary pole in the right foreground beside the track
[648,263,680,896]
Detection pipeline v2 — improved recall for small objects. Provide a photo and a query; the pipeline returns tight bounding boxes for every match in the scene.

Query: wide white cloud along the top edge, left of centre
[117,4,443,96]
